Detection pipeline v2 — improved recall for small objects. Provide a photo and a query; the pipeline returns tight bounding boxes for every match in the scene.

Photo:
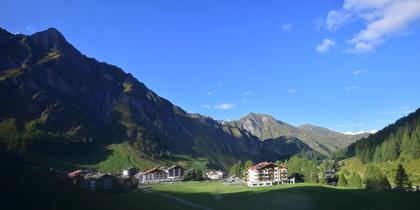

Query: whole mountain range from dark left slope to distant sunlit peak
[0,28,366,168]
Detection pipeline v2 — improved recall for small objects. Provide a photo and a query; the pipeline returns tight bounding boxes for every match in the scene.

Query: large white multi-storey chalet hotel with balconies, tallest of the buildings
[247,162,295,187]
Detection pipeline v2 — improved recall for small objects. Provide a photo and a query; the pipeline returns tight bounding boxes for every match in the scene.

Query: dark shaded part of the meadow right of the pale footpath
[155,186,420,210]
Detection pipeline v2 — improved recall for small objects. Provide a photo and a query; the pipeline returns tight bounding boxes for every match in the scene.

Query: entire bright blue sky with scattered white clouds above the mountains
[0,0,420,132]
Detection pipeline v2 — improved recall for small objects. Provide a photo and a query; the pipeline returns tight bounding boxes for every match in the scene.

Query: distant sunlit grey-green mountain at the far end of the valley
[230,113,368,155]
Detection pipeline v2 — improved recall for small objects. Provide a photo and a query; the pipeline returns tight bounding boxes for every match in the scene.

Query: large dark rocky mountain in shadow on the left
[0,28,320,167]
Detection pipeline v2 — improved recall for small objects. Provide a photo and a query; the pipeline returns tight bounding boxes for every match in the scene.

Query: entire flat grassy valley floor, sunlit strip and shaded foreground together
[18,183,420,210]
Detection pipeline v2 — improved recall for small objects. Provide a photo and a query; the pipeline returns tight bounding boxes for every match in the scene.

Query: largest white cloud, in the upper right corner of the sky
[326,0,420,53]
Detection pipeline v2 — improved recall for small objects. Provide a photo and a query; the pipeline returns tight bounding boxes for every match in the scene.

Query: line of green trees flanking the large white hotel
[229,156,411,190]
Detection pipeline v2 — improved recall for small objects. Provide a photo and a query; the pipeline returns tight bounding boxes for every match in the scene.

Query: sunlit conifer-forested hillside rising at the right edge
[334,109,420,185]
